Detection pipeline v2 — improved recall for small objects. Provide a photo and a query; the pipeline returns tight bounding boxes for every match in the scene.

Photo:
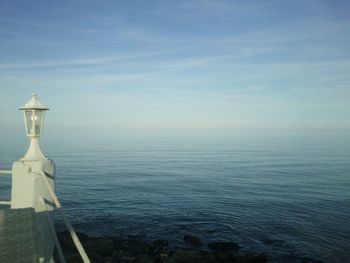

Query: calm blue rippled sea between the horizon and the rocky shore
[0,128,350,262]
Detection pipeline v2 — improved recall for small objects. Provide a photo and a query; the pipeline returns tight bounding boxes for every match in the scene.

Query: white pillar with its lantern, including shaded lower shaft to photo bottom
[11,94,55,262]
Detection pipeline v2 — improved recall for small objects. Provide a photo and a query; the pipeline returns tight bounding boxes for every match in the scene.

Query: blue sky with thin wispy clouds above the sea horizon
[0,0,350,129]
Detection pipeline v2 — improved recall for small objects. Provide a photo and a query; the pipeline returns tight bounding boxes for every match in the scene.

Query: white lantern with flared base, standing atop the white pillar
[20,93,49,161]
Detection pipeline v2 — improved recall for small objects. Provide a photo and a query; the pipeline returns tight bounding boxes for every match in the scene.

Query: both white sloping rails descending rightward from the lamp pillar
[39,172,90,263]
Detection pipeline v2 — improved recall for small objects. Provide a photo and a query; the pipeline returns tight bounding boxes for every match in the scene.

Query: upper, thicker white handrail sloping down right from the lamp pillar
[39,172,90,263]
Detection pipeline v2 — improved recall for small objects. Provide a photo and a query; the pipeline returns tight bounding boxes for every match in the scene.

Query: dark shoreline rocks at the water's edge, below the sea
[55,231,322,263]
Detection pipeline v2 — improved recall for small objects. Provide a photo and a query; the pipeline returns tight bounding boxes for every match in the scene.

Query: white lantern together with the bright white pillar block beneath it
[11,93,55,212]
